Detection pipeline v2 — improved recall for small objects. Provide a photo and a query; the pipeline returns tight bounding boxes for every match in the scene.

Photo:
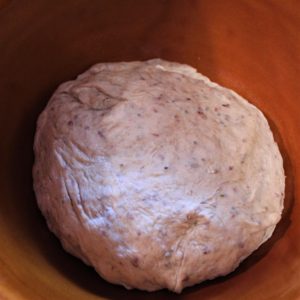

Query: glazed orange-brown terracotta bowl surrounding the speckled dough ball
[0,0,300,300]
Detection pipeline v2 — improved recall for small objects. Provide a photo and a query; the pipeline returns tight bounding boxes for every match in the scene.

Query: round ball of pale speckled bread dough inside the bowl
[33,59,285,292]
